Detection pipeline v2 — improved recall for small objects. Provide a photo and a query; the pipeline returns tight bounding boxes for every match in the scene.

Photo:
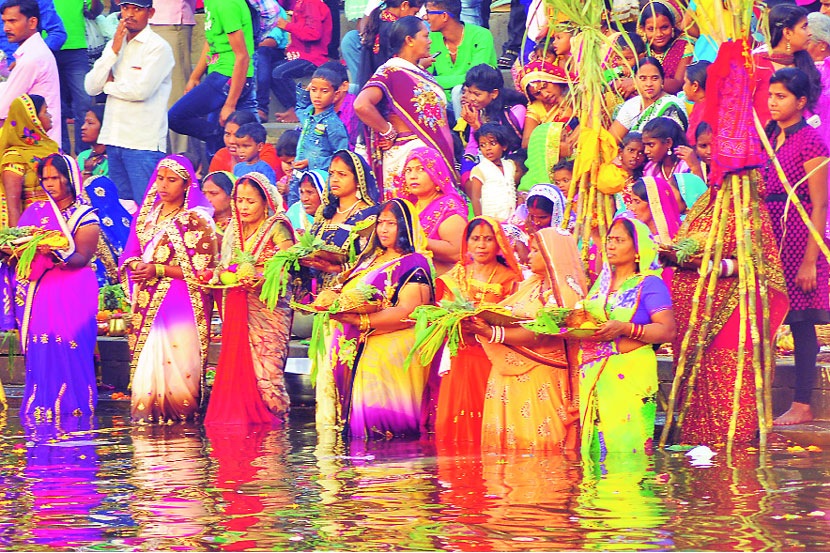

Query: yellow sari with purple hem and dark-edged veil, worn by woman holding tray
[329,199,432,439]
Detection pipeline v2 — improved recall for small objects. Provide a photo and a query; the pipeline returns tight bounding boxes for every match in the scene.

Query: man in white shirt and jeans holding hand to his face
[84,0,175,204]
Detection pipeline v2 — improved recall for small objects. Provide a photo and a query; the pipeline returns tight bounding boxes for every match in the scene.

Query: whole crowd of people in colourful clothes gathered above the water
[0,0,830,462]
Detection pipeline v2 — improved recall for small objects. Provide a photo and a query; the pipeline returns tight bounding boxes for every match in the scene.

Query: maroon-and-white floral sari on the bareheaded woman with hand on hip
[366,57,454,200]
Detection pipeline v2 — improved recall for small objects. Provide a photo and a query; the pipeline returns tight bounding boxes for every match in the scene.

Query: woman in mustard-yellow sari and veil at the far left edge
[0,94,60,228]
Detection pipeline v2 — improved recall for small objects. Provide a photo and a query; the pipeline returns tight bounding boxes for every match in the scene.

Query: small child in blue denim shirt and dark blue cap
[290,63,349,205]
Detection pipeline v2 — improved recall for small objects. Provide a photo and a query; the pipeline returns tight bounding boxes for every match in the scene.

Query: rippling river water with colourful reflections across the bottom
[0,405,830,551]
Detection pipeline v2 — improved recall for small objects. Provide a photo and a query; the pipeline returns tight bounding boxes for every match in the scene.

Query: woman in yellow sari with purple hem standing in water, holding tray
[329,199,433,438]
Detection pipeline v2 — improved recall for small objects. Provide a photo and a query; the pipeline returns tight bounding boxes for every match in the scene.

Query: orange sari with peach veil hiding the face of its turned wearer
[481,224,586,451]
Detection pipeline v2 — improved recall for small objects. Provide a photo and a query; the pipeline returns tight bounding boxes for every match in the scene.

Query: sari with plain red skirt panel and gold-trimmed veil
[205,172,294,425]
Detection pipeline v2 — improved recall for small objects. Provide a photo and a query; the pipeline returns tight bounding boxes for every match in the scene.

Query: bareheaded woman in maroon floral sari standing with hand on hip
[354,15,454,200]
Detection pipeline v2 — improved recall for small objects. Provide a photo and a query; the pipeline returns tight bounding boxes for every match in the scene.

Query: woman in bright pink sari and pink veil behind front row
[404,148,469,276]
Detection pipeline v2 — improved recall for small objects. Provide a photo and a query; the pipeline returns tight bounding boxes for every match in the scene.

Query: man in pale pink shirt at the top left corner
[0,0,61,144]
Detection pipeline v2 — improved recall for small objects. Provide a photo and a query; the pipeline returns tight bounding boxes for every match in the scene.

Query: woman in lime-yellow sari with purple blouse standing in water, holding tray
[579,215,675,460]
